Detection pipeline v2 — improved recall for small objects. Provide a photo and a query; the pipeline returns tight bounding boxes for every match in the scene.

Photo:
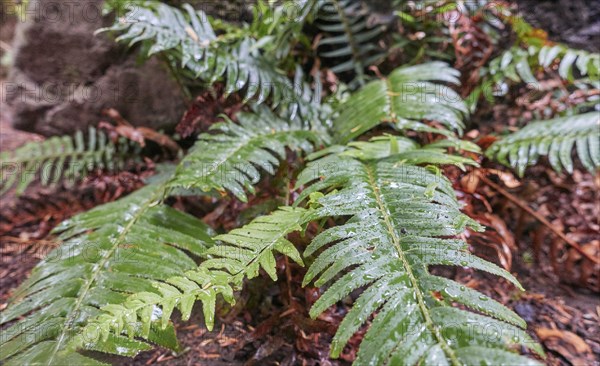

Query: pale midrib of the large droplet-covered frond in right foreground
[364,163,461,366]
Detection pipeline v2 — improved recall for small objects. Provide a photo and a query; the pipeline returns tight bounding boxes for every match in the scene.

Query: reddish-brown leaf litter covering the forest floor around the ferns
[0,0,600,366]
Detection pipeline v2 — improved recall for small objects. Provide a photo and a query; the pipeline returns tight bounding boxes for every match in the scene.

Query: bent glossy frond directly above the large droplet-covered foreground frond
[333,62,468,143]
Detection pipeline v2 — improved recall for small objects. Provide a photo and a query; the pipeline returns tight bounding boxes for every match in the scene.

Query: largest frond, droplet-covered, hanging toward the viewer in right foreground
[298,154,542,365]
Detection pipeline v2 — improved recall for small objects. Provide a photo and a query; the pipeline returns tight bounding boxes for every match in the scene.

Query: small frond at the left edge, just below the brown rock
[0,127,140,194]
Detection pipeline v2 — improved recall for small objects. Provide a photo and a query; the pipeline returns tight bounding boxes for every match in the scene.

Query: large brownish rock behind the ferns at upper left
[2,0,185,136]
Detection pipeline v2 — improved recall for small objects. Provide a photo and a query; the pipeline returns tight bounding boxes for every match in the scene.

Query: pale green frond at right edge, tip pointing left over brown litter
[486,112,600,176]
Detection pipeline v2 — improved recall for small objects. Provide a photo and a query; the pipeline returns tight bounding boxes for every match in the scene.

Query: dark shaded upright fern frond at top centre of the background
[316,0,383,85]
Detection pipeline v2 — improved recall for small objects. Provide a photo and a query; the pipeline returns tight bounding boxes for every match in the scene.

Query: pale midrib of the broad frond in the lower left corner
[47,183,165,366]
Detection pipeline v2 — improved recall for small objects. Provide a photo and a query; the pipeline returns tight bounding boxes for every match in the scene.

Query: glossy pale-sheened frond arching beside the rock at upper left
[100,1,296,106]
